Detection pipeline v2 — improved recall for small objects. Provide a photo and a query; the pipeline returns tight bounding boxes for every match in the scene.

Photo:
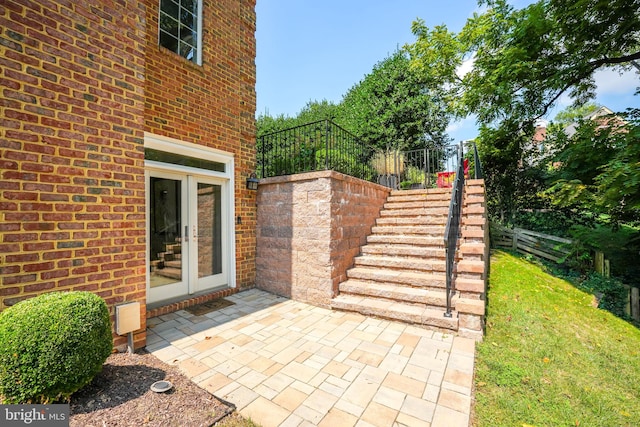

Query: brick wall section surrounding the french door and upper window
[145,0,256,287]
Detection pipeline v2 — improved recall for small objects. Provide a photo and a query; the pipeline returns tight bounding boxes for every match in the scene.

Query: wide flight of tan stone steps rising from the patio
[331,188,460,331]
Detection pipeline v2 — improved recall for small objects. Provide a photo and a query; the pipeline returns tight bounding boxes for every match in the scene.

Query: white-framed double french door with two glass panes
[147,171,229,303]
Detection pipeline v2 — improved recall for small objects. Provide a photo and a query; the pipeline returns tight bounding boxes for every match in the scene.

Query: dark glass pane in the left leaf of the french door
[149,177,183,288]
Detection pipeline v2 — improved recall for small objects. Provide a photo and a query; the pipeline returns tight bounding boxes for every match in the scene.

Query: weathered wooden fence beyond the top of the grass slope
[491,224,640,321]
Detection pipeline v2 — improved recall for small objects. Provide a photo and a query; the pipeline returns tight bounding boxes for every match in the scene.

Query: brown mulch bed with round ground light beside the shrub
[70,352,234,427]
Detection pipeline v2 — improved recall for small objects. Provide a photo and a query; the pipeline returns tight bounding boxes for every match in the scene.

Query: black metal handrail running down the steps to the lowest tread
[444,142,465,317]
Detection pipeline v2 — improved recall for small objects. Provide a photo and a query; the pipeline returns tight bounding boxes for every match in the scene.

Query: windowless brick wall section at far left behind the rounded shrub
[0,0,146,345]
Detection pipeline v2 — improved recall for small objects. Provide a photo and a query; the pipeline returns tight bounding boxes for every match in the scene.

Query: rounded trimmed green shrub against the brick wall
[0,292,113,403]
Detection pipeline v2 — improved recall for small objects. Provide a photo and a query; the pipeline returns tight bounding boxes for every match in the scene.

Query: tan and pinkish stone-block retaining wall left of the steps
[256,171,389,307]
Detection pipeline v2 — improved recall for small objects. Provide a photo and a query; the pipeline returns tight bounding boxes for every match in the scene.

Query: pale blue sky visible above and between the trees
[256,0,640,141]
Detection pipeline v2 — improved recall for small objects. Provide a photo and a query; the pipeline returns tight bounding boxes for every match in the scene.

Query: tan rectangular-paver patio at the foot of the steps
[147,289,475,427]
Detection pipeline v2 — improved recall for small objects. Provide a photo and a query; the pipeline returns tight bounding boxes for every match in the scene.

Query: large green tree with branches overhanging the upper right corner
[409,0,640,222]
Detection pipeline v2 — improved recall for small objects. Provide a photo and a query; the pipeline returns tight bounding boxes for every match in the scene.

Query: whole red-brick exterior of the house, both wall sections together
[0,0,256,347]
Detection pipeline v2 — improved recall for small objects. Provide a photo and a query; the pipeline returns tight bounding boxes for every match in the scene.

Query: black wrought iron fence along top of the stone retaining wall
[257,120,468,189]
